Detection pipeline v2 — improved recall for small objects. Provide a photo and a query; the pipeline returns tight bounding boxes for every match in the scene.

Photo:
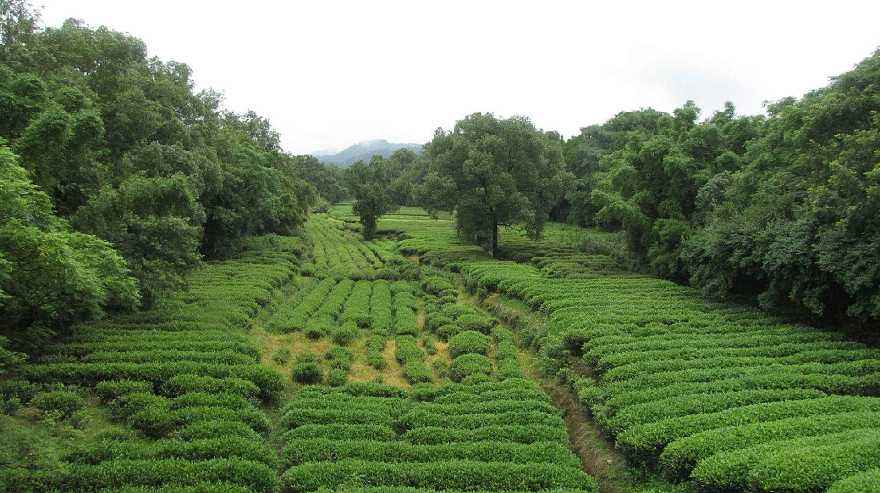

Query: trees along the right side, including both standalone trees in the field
[350,51,880,328]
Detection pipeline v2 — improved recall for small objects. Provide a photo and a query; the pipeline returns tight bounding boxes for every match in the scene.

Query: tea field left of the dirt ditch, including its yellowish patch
[0,215,598,492]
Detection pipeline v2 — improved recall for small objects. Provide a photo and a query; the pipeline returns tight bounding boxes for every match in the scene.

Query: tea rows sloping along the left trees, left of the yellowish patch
[0,237,303,492]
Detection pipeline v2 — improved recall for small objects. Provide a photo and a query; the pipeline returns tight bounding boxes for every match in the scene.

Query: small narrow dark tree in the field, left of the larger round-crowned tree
[348,156,397,240]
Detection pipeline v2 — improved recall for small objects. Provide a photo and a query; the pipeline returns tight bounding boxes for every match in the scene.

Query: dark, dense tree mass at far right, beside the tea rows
[684,52,880,323]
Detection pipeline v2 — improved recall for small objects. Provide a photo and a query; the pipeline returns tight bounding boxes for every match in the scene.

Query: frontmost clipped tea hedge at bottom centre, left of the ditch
[282,460,598,493]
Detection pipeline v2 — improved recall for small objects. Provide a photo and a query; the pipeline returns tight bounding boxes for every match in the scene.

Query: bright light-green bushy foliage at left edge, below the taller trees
[0,140,139,338]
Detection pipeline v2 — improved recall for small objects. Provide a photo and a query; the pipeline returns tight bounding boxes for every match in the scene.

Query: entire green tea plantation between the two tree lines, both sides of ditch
[0,209,880,493]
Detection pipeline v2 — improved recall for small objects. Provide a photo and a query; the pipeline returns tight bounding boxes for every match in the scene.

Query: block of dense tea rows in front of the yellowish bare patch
[282,380,596,492]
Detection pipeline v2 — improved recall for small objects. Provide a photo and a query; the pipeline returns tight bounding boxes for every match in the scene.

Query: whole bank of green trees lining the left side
[0,0,316,347]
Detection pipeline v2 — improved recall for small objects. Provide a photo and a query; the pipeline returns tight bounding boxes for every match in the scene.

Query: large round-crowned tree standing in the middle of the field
[423,113,572,256]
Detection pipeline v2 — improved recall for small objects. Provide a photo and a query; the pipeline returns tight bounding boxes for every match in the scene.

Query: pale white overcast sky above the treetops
[34,0,880,153]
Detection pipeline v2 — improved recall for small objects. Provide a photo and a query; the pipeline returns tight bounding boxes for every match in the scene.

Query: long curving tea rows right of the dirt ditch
[390,218,880,492]
